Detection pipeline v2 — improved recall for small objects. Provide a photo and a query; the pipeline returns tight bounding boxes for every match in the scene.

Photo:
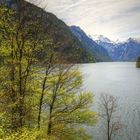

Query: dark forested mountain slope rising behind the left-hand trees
[0,0,95,63]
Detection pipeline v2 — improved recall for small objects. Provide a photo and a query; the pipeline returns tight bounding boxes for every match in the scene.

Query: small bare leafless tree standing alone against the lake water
[100,94,123,140]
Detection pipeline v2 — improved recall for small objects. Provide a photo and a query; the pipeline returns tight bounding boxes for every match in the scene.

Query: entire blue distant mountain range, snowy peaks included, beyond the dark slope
[70,26,140,61]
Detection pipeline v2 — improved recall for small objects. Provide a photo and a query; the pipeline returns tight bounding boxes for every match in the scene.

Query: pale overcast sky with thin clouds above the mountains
[28,0,140,40]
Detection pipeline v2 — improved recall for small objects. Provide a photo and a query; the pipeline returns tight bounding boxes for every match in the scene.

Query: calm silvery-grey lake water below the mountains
[80,62,140,140]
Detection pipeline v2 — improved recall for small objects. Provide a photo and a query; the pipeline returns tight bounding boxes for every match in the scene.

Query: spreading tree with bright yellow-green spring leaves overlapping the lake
[42,64,97,139]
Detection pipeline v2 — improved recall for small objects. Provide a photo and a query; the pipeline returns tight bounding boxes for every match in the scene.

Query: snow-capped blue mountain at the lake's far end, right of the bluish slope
[92,36,140,61]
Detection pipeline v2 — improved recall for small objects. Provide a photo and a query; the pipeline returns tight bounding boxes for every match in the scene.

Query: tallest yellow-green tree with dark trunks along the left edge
[0,1,46,129]
